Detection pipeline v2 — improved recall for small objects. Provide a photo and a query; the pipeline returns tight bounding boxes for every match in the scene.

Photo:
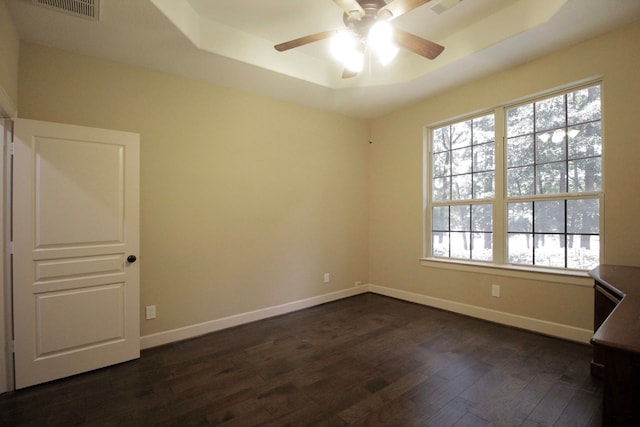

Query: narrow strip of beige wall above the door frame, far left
[0,0,20,117]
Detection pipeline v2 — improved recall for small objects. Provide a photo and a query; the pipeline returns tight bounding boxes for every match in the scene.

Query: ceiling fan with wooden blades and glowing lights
[274,0,444,78]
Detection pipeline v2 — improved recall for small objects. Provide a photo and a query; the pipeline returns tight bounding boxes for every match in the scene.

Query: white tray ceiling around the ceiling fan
[7,0,640,118]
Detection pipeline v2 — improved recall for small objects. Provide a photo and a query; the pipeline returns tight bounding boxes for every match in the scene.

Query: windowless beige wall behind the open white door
[19,43,370,335]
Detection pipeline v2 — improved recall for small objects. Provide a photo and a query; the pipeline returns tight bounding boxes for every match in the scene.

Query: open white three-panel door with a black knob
[12,119,140,388]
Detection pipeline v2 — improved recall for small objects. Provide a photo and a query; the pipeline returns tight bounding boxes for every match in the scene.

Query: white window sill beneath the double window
[420,258,593,287]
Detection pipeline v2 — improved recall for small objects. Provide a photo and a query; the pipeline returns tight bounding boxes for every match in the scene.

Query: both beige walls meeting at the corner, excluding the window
[19,19,640,344]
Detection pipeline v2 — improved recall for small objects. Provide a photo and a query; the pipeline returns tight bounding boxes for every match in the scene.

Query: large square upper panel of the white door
[33,137,124,248]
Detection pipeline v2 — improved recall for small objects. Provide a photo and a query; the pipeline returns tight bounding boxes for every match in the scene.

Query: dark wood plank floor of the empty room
[0,294,602,427]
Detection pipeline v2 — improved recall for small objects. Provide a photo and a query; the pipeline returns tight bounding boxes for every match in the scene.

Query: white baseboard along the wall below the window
[368,284,593,344]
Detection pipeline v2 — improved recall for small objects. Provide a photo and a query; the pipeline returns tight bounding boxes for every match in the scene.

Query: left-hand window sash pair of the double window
[431,115,495,261]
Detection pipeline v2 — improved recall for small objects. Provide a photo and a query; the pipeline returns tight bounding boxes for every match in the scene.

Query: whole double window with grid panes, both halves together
[427,84,602,270]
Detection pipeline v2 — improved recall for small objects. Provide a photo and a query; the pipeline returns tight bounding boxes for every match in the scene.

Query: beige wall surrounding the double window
[369,23,640,329]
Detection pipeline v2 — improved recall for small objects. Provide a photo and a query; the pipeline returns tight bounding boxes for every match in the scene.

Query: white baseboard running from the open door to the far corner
[140,285,369,350]
